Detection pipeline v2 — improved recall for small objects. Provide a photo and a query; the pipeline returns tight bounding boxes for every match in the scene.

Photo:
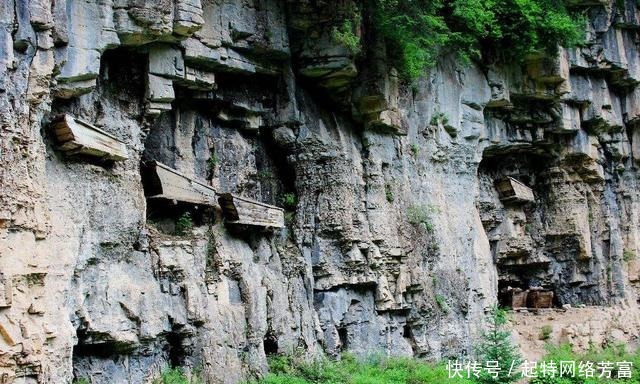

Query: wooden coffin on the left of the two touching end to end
[143,161,217,206]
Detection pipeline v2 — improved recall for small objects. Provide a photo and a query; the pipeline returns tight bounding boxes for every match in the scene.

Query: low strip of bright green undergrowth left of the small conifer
[257,354,472,384]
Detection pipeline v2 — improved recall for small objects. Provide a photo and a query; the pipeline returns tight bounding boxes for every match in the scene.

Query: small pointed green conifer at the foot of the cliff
[477,307,522,384]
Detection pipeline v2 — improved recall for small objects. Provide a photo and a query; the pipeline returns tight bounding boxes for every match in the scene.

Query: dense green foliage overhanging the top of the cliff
[374,0,584,79]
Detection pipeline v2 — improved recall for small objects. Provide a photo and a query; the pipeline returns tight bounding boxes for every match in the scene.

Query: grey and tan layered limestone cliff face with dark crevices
[0,0,640,383]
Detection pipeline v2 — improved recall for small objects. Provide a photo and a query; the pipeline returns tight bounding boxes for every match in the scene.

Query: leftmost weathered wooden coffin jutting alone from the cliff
[52,114,128,161]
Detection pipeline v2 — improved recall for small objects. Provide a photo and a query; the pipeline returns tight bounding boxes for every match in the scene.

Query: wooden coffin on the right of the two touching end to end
[218,193,284,228]
